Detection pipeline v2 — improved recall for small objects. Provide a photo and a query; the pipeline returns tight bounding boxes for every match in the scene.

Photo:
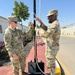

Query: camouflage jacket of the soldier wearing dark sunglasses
[4,27,23,53]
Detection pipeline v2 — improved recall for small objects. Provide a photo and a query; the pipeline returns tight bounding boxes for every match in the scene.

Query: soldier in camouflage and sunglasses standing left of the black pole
[4,16,32,75]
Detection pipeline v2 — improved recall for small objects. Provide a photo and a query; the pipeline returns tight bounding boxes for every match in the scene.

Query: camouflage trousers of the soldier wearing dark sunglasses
[8,49,26,75]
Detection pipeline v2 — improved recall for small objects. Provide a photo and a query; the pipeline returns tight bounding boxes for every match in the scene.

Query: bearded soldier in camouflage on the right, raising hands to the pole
[35,10,61,75]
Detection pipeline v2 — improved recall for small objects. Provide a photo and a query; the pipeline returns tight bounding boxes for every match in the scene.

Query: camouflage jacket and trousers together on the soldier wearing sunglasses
[4,27,26,75]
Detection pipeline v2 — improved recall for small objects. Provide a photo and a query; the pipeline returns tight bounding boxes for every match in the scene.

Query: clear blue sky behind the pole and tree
[0,0,75,27]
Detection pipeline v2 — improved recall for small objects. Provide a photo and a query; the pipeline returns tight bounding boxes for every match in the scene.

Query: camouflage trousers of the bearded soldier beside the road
[45,46,59,75]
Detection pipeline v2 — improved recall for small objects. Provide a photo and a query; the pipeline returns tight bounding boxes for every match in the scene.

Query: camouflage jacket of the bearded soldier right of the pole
[41,20,61,48]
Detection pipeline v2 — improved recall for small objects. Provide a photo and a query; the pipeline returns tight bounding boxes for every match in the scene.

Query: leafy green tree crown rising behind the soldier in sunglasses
[12,1,30,22]
